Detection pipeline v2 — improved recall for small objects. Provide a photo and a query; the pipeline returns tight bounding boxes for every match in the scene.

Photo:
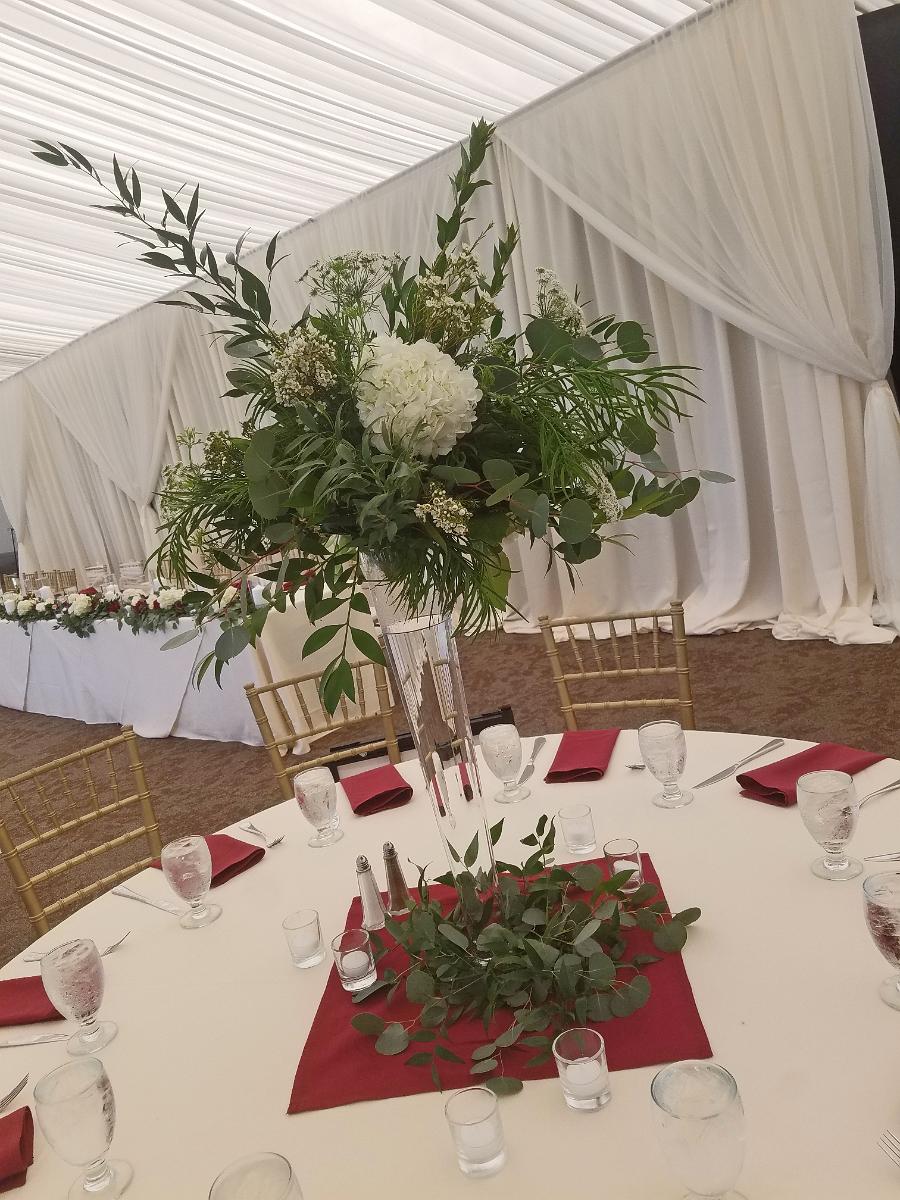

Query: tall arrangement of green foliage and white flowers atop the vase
[35,121,727,710]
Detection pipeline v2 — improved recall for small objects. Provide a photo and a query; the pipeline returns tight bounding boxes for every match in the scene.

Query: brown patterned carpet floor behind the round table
[0,630,900,962]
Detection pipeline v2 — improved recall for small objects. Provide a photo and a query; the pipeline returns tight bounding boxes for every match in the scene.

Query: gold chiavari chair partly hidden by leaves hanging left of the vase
[245,661,400,800]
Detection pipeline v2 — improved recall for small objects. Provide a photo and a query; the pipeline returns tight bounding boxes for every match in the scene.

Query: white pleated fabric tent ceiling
[0,0,893,378]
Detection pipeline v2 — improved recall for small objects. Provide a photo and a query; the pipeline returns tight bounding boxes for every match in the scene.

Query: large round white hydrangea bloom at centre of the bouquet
[356,334,481,458]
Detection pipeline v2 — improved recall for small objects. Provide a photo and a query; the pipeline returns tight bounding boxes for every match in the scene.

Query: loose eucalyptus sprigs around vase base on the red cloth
[350,816,701,1094]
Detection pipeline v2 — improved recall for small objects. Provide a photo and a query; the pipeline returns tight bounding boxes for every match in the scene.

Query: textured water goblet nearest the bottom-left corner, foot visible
[35,1058,134,1200]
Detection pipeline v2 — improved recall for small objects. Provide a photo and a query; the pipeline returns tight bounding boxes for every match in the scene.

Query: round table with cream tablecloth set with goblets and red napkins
[0,730,900,1200]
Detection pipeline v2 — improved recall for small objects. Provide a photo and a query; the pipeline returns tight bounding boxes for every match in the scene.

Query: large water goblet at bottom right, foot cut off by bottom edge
[650,1060,744,1200]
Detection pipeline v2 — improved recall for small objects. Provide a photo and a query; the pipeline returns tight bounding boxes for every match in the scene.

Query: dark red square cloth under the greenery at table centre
[288,854,713,1112]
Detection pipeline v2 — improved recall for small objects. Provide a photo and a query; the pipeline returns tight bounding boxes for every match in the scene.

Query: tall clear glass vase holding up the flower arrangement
[365,560,497,917]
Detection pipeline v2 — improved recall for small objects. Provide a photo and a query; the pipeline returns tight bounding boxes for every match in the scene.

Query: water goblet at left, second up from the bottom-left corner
[41,937,119,1055]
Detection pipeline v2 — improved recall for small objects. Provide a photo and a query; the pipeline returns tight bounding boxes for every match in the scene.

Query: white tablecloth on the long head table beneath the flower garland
[0,619,262,745]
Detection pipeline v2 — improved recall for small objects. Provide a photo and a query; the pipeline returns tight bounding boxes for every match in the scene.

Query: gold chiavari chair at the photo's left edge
[0,726,161,936]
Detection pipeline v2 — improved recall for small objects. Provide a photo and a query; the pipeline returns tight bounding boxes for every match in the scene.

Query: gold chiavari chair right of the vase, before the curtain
[538,600,696,730]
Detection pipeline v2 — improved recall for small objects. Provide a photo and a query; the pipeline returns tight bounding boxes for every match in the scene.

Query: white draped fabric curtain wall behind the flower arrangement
[0,0,900,643]
